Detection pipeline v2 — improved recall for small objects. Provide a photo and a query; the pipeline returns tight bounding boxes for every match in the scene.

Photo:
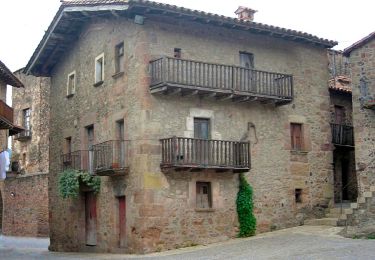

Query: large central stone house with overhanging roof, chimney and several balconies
[25,0,336,253]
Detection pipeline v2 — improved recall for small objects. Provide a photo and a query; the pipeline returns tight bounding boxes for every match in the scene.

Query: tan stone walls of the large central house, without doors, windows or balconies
[49,14,333,253]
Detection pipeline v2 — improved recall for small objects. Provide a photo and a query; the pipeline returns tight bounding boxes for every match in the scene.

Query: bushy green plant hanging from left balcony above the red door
[59,169,100,199]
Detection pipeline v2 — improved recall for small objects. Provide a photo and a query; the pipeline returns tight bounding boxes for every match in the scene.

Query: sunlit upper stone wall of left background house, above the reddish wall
[12,70,50,174]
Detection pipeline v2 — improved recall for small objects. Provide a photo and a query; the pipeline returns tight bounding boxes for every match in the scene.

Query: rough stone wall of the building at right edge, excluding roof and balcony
[350,36,375,192]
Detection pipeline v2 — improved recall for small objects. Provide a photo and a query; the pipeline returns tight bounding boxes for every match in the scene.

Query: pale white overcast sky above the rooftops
[0,0,375,71]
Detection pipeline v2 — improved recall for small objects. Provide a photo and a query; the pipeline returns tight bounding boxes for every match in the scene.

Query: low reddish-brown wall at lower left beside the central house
[0,173,49,237]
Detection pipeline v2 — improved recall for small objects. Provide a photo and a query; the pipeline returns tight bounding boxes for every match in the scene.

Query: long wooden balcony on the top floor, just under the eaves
[150,57,293,105]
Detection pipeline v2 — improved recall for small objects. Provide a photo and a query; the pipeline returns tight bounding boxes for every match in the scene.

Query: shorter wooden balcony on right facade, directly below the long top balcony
[161,137,250,172]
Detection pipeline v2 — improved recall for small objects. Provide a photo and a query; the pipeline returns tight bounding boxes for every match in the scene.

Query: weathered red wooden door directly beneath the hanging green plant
[85,192,96,246]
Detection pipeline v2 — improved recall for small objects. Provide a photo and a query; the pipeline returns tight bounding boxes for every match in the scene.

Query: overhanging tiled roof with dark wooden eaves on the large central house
[25,0,337,76]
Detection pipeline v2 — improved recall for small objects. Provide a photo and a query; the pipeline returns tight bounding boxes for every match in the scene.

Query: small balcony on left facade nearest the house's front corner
[93,140,129,176]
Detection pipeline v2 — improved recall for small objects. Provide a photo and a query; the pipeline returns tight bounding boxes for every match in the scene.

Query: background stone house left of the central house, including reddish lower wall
[3,69,50,237]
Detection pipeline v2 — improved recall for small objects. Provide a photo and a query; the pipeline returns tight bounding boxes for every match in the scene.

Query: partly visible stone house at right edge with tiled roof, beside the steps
[343,32,375,236]
